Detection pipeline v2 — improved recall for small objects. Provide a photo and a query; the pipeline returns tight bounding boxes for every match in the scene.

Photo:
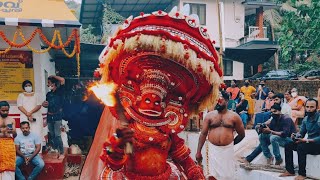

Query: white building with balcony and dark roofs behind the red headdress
[80,0,278,80]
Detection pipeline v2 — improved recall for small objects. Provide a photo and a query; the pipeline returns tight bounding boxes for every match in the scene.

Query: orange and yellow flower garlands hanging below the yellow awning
[0,27,80,77]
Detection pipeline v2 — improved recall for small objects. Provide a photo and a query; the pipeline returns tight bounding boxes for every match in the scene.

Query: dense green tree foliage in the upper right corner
[279,0,320,63]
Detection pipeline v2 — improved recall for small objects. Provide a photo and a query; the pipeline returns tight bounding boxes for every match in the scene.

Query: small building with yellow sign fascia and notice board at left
[0,0,81,129]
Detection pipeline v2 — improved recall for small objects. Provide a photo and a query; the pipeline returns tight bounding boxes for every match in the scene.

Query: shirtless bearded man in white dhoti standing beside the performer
[196,92,245,180]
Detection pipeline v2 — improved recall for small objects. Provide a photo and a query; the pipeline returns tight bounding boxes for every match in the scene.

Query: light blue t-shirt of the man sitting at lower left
[14,132,41,157]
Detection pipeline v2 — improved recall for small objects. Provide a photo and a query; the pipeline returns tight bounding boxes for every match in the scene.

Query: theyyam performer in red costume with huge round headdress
[80,4,222,180]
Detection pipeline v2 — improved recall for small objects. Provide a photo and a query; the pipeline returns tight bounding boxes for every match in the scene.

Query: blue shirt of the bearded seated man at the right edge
[300,112,320,144]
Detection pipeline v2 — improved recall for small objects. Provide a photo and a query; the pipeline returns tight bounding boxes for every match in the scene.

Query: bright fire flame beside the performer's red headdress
[89,83,117,107]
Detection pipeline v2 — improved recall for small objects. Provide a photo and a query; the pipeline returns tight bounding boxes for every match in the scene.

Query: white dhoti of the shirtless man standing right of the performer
[209,142,236,180]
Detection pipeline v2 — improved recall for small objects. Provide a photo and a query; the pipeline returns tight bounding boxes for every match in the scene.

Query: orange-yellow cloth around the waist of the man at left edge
[0,138,16,173]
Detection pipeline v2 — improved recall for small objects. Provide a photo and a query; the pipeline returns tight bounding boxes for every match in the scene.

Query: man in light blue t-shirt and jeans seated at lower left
[14,121,44,180]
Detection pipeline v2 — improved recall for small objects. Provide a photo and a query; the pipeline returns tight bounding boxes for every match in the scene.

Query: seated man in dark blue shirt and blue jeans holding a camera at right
[259,104,295,165]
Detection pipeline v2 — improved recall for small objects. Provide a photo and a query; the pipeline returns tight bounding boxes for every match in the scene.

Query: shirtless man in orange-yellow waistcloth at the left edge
[0,101,17,180]
